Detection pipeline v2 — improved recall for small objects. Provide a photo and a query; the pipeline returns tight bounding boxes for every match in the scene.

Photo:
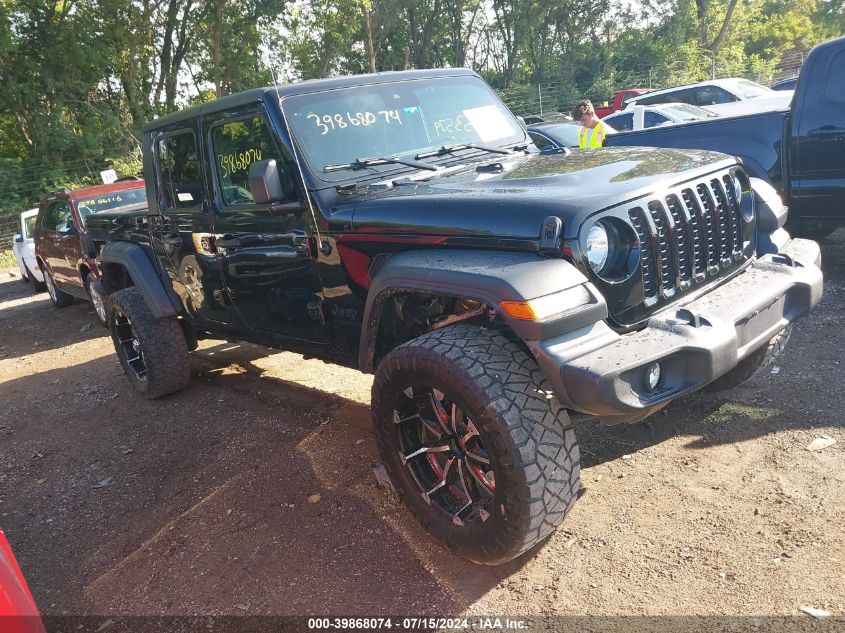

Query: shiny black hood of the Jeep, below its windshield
[342,147,736,239]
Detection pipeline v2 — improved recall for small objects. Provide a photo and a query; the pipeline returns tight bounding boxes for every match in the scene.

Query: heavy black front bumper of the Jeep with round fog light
[532,239,822,423]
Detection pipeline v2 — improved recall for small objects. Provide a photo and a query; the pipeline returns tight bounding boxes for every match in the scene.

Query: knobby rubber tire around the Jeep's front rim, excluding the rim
[372,325,580,565]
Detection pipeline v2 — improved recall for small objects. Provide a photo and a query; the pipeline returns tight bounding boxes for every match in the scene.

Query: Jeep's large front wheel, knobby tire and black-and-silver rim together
[372,325,580,565]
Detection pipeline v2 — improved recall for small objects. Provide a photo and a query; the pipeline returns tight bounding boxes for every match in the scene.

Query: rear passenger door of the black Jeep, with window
[150,128,231,327]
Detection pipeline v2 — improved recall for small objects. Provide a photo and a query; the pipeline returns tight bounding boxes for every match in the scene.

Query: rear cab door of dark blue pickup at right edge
[790,49,845,217]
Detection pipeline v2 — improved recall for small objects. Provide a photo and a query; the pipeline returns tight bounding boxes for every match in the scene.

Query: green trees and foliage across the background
[0,0,845,208]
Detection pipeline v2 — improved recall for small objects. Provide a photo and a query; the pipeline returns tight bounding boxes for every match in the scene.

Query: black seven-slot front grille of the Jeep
[628,174,745,305]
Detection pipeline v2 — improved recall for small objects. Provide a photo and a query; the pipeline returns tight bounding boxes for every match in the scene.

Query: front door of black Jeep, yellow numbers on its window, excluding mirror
[204,104,329,342]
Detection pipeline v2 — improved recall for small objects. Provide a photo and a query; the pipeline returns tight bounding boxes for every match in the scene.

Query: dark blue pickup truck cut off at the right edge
[605,37,845,237]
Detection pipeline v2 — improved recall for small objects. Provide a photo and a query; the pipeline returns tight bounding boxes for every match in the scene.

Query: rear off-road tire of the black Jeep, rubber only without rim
[108,287,191,400]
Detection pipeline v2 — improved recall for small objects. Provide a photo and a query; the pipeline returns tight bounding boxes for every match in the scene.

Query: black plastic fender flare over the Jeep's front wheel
[358,250,608,372]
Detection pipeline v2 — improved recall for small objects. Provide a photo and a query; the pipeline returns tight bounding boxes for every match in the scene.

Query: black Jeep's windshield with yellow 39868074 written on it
[283,77,525,181]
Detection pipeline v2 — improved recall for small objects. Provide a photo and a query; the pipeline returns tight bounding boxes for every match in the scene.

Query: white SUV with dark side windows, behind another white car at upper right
[626,78,792,116]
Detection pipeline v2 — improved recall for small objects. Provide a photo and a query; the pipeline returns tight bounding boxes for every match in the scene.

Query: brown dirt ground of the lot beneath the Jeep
[0,230,845,618]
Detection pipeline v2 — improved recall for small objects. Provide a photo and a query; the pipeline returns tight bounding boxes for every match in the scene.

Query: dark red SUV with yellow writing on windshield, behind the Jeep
[33,180,147,324]
